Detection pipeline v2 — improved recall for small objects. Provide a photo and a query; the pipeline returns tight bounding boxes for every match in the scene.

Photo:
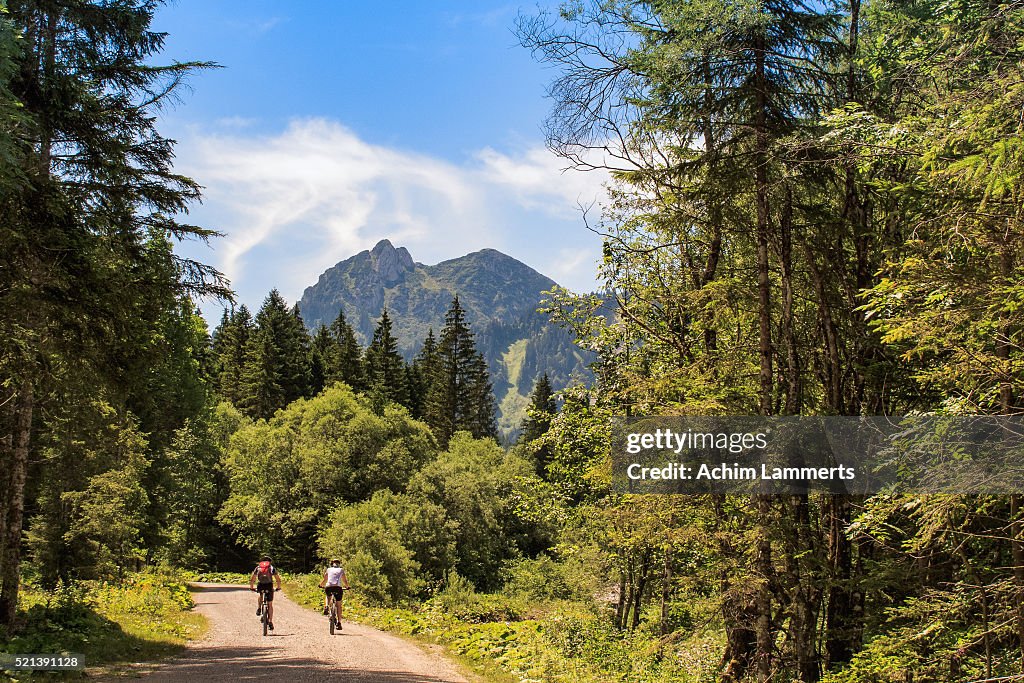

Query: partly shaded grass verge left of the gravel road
[0,573,207,681]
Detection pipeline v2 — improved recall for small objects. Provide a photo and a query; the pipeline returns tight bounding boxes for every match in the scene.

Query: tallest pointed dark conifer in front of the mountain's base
[424,296,497,445]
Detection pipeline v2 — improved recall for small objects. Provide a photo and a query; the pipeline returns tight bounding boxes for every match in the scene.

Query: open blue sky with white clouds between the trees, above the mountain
[154,0,605,321]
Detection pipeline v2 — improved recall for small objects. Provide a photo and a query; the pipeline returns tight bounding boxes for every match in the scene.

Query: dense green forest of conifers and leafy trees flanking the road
[0,0,1024,683]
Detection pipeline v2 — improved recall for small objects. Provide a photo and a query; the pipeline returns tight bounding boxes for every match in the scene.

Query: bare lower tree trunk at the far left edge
[0,380,35,629]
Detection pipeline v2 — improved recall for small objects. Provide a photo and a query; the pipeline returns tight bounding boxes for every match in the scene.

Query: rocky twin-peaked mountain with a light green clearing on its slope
[299,240,593,436]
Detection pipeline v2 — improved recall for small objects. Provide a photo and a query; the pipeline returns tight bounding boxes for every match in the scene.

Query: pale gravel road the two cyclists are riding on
[97,584,468,683]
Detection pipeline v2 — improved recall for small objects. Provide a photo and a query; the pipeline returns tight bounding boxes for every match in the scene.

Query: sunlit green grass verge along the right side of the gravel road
[285,575,722,683]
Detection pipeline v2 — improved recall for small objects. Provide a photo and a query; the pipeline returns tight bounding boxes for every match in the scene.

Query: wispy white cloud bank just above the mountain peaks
[179,119,605,315]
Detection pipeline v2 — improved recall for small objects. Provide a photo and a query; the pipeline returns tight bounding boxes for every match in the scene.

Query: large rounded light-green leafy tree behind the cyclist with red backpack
[219,384,435,568]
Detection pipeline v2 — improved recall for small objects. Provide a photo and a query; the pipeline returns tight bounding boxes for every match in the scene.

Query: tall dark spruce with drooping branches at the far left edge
[0,0,228,626]
